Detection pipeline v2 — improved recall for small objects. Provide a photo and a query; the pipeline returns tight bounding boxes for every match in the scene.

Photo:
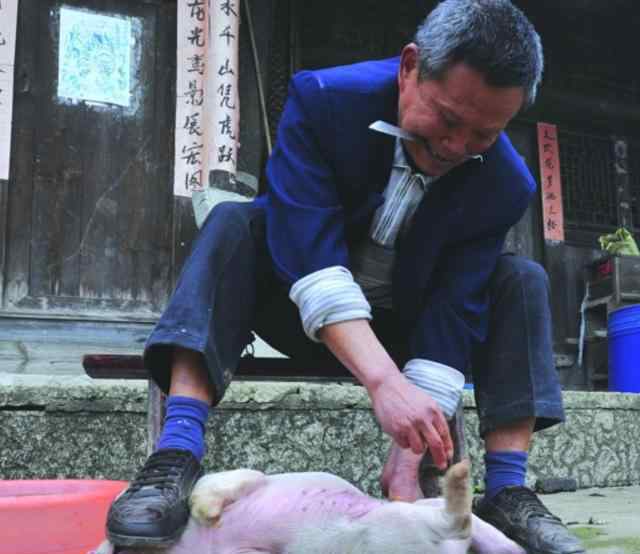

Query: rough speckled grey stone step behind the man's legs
[0,373,640,494]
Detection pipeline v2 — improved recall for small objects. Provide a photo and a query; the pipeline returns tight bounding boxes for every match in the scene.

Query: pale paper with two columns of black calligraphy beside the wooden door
[174,0,240,196]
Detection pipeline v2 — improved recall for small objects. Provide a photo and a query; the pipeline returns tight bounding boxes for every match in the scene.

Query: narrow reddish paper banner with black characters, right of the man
[538,123,564,242]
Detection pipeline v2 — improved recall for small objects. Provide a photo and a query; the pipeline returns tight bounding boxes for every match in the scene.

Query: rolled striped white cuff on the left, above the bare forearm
[289,265,371,342]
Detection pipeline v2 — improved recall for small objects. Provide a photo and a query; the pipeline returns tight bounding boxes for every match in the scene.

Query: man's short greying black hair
[415,0,544,107]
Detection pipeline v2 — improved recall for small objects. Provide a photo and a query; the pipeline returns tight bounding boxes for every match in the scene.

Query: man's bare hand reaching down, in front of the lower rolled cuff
[368,372,453,469]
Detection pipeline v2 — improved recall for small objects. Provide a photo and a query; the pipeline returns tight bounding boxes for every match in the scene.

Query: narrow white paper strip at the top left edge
[0,0,18,179]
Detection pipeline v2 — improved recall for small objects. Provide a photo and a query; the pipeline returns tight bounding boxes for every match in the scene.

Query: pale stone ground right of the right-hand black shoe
[541,486,640,554]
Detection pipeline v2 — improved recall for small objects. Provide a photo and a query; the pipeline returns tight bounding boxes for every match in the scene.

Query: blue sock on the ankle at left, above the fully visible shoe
[156,396,209,461]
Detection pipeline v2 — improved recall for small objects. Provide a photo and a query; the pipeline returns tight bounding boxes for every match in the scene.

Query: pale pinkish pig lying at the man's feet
[95,461,524,554]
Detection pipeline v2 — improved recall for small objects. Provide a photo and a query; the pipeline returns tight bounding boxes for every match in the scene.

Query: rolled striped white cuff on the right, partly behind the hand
[402,358,464,419]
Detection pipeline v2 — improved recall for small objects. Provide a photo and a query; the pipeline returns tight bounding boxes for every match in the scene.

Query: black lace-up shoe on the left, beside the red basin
[107,448,202,547]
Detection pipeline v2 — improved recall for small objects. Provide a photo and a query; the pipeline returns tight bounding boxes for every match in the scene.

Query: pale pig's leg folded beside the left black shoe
[190,469,266,525]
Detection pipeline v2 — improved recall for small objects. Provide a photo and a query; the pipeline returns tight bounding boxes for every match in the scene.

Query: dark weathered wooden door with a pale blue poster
[0,0,195,322]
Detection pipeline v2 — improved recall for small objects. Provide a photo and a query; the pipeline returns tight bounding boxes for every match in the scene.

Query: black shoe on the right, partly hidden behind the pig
[473,487,586,554]
